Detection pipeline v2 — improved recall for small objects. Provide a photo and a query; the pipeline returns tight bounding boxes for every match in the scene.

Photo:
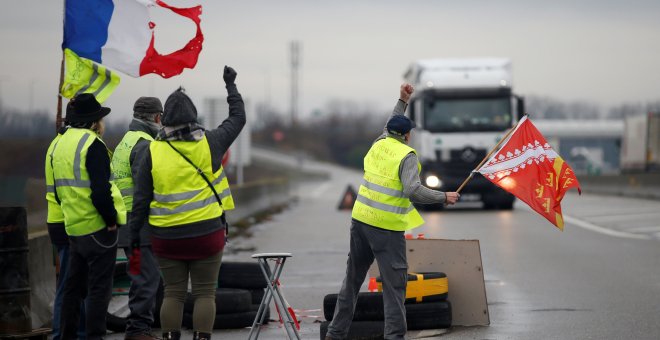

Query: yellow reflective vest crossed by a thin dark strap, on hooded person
[149,137,234,228]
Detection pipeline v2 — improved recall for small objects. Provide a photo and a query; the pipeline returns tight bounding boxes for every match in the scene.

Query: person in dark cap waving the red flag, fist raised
[326,84,459,340]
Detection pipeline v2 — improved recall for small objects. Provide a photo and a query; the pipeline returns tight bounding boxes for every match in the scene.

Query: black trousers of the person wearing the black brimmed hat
[60,228,117,340]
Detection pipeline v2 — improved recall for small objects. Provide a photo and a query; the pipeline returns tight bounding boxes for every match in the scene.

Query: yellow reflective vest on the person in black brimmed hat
[52,128,126,236]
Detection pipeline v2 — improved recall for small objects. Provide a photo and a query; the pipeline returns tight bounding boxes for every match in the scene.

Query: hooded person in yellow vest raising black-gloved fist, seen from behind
[129,66,245,340]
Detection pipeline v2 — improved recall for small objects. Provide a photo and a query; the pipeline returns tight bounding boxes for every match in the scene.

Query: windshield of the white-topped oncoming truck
[424,97,512,132]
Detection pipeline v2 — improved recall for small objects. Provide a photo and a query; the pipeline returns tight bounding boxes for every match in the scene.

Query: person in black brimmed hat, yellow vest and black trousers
[52,93,126,340]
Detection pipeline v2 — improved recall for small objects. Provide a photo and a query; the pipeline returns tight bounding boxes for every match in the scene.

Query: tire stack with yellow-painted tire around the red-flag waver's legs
[320,273,451,339]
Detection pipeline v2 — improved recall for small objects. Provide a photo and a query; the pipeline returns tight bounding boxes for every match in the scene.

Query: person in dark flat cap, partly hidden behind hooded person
[112,97,163,340]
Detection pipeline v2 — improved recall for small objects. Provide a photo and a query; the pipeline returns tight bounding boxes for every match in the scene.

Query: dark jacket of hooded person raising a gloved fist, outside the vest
[129,84,245,239]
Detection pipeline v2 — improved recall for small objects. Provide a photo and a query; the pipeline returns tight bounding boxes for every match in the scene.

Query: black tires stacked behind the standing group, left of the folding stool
[107,262,270,332]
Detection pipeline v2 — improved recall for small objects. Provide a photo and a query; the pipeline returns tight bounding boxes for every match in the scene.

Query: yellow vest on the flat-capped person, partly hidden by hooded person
[112,131,154,212]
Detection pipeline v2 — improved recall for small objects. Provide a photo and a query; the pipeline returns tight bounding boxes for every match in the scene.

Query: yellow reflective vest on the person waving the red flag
[352,137,424,231]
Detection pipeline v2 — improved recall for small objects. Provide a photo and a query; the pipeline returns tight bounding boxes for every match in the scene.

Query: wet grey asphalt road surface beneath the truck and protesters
[105,150,660,339]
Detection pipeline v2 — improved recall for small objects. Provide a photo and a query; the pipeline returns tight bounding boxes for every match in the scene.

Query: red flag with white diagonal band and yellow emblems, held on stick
[478,116,581,230]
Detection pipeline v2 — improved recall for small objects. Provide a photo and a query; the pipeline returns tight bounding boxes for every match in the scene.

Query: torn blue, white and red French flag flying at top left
[62,0,204,78]
